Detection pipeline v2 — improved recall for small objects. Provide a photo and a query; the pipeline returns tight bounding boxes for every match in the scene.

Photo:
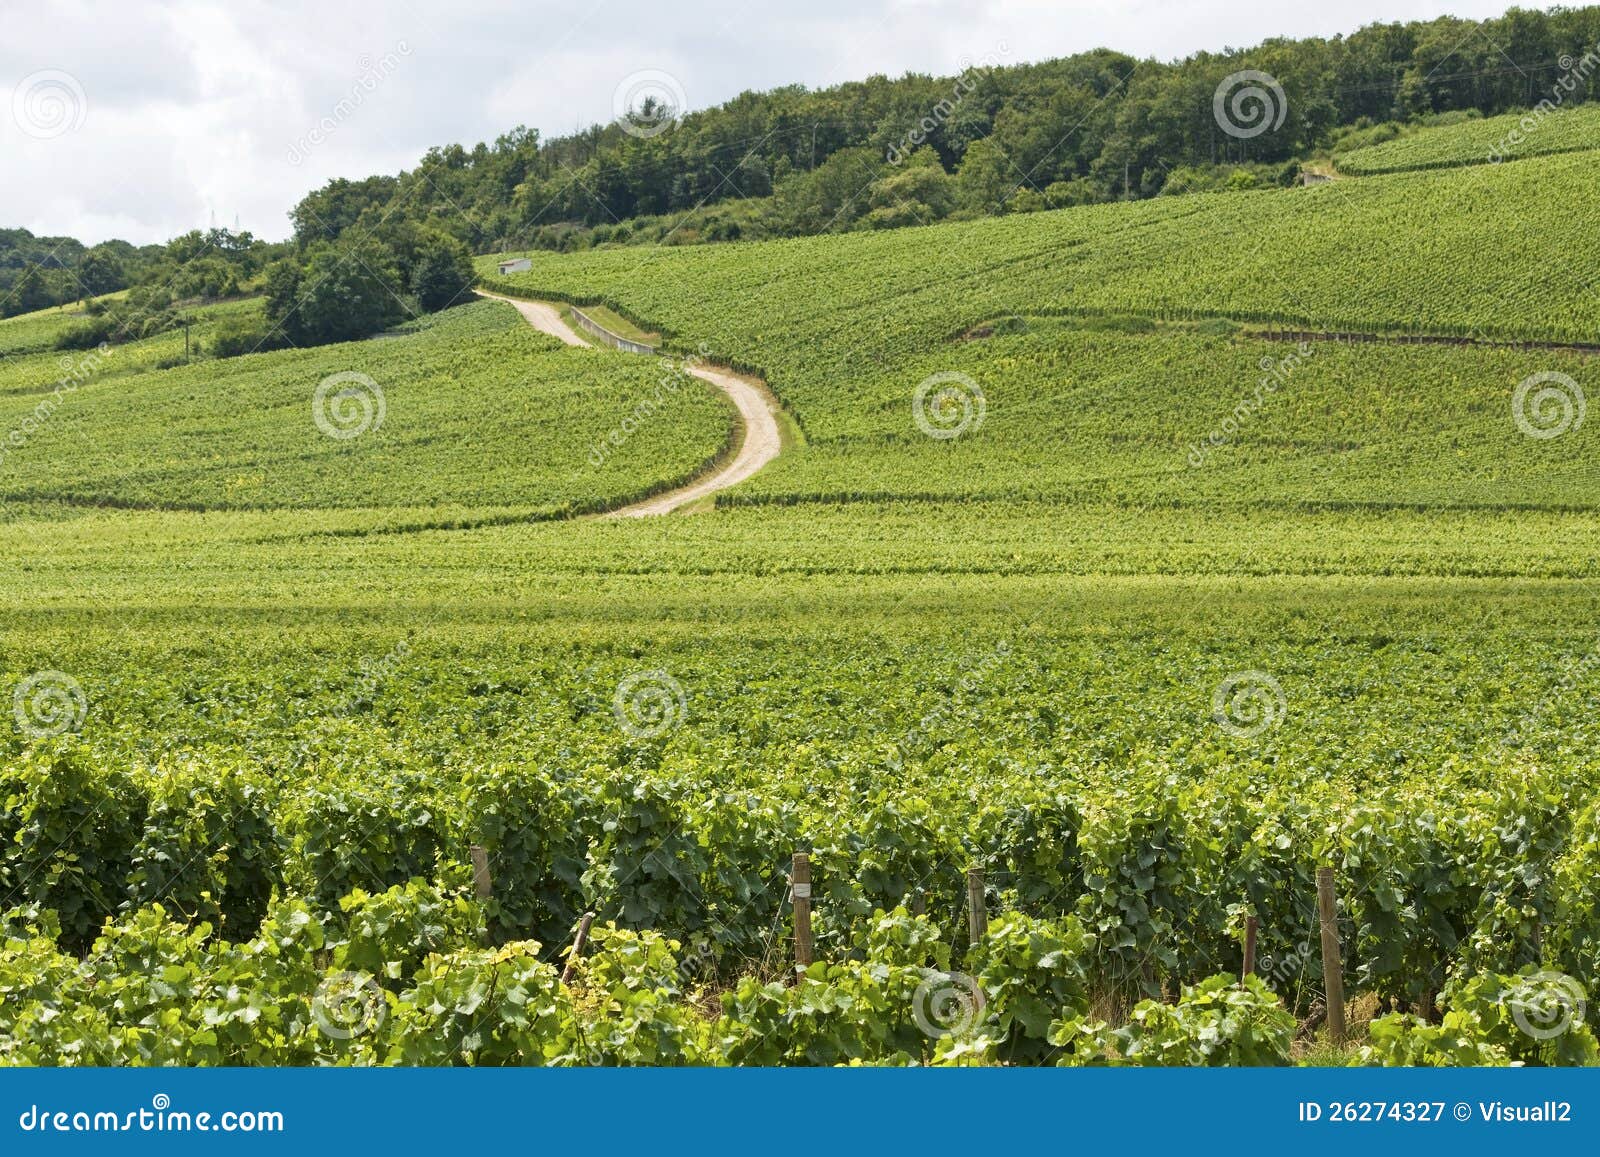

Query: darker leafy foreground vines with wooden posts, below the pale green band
[3,579,1600,1063]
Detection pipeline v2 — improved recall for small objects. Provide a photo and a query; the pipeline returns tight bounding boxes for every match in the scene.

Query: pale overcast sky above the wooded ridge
[0,0,1509,243]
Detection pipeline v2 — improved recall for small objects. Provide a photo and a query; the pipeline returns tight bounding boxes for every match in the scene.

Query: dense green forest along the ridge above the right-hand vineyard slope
[281,6,1600,253]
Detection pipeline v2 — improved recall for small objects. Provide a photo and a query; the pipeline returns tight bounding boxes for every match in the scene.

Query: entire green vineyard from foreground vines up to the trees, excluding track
[0,114,1600,1066]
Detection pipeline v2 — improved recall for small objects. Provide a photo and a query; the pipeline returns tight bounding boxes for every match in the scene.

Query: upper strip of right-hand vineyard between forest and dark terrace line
[485,148,1600,344]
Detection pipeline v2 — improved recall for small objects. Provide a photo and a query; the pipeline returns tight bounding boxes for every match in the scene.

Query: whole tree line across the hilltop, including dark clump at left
[12,6,1600,352]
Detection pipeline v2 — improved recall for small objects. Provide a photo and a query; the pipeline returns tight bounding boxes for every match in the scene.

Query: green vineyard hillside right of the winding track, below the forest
[480,157,1600,518]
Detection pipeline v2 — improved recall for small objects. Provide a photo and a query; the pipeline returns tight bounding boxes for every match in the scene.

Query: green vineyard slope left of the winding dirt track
[0,304,730,512]
